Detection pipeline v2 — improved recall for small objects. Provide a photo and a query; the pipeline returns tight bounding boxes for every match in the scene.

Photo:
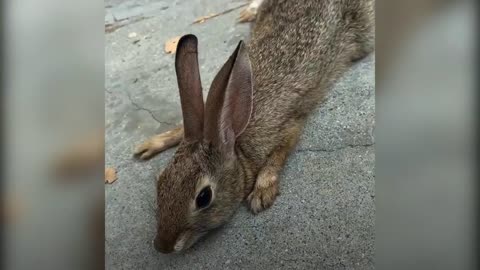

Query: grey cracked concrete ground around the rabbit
[105,0,375,270]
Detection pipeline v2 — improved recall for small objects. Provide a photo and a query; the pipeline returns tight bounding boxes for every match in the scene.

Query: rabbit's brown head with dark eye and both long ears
[154,35,253,253]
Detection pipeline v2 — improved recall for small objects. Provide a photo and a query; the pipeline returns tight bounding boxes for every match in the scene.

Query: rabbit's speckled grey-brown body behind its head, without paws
[241,0,374,160]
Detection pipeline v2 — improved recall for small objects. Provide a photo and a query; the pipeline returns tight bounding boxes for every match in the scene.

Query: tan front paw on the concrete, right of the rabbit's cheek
[247,171,279,214]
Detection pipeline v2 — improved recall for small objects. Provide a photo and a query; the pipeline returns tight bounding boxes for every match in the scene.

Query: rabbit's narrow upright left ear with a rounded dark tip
[175,35,204,141]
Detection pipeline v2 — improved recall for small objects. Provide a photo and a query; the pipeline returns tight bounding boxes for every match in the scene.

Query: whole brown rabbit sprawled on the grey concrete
[136,0,374,253]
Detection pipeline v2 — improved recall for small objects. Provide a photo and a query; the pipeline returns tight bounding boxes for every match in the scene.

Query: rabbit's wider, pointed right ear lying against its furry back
[204,41,253,154]
